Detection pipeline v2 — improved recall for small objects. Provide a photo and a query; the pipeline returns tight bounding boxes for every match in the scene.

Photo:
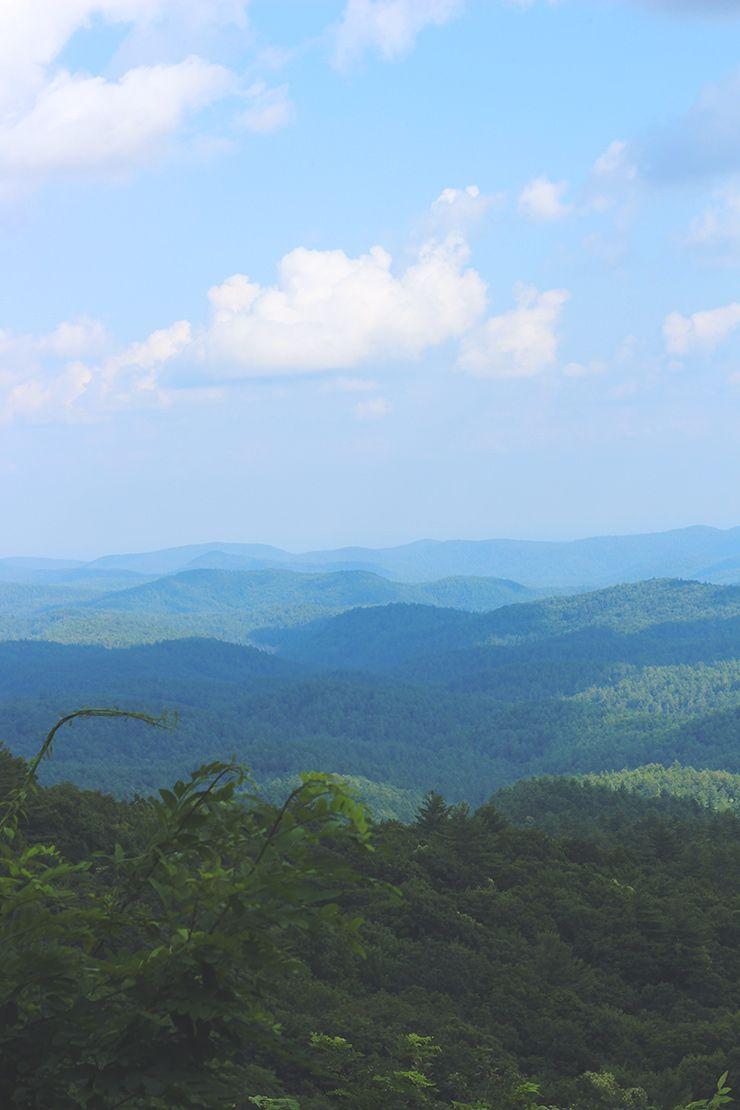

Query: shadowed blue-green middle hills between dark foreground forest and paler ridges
[0,582,740,816]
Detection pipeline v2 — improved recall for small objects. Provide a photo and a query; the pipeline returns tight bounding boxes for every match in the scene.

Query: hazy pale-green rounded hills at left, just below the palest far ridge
[0,569,543,647]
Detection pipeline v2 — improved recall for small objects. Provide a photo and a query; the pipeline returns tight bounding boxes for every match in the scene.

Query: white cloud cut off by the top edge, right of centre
[334,0,464,70]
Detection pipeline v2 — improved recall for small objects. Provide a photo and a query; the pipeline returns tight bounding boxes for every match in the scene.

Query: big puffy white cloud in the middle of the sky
[201,235,486,377]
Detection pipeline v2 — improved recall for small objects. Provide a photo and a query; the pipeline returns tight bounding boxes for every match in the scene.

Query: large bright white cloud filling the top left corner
[0,0,246,186]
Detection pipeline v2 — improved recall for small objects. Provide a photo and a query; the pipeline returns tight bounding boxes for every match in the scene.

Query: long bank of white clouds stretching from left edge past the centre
[0,185,568,421]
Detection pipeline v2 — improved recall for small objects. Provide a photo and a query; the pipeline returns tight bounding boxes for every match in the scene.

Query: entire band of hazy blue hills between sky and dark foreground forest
[0,527,740,816]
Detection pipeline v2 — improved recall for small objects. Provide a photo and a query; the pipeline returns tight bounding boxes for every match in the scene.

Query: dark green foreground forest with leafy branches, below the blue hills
[0,737,740,1110]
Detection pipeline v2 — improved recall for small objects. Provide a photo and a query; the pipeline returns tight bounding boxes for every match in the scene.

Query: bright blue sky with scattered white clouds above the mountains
[0,0,740,558]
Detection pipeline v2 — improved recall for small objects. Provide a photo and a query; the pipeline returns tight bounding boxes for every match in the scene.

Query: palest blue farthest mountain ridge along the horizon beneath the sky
[5,525,740,589]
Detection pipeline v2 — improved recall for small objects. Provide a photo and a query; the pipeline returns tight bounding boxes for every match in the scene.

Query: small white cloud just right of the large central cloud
[459,285,570,377]
